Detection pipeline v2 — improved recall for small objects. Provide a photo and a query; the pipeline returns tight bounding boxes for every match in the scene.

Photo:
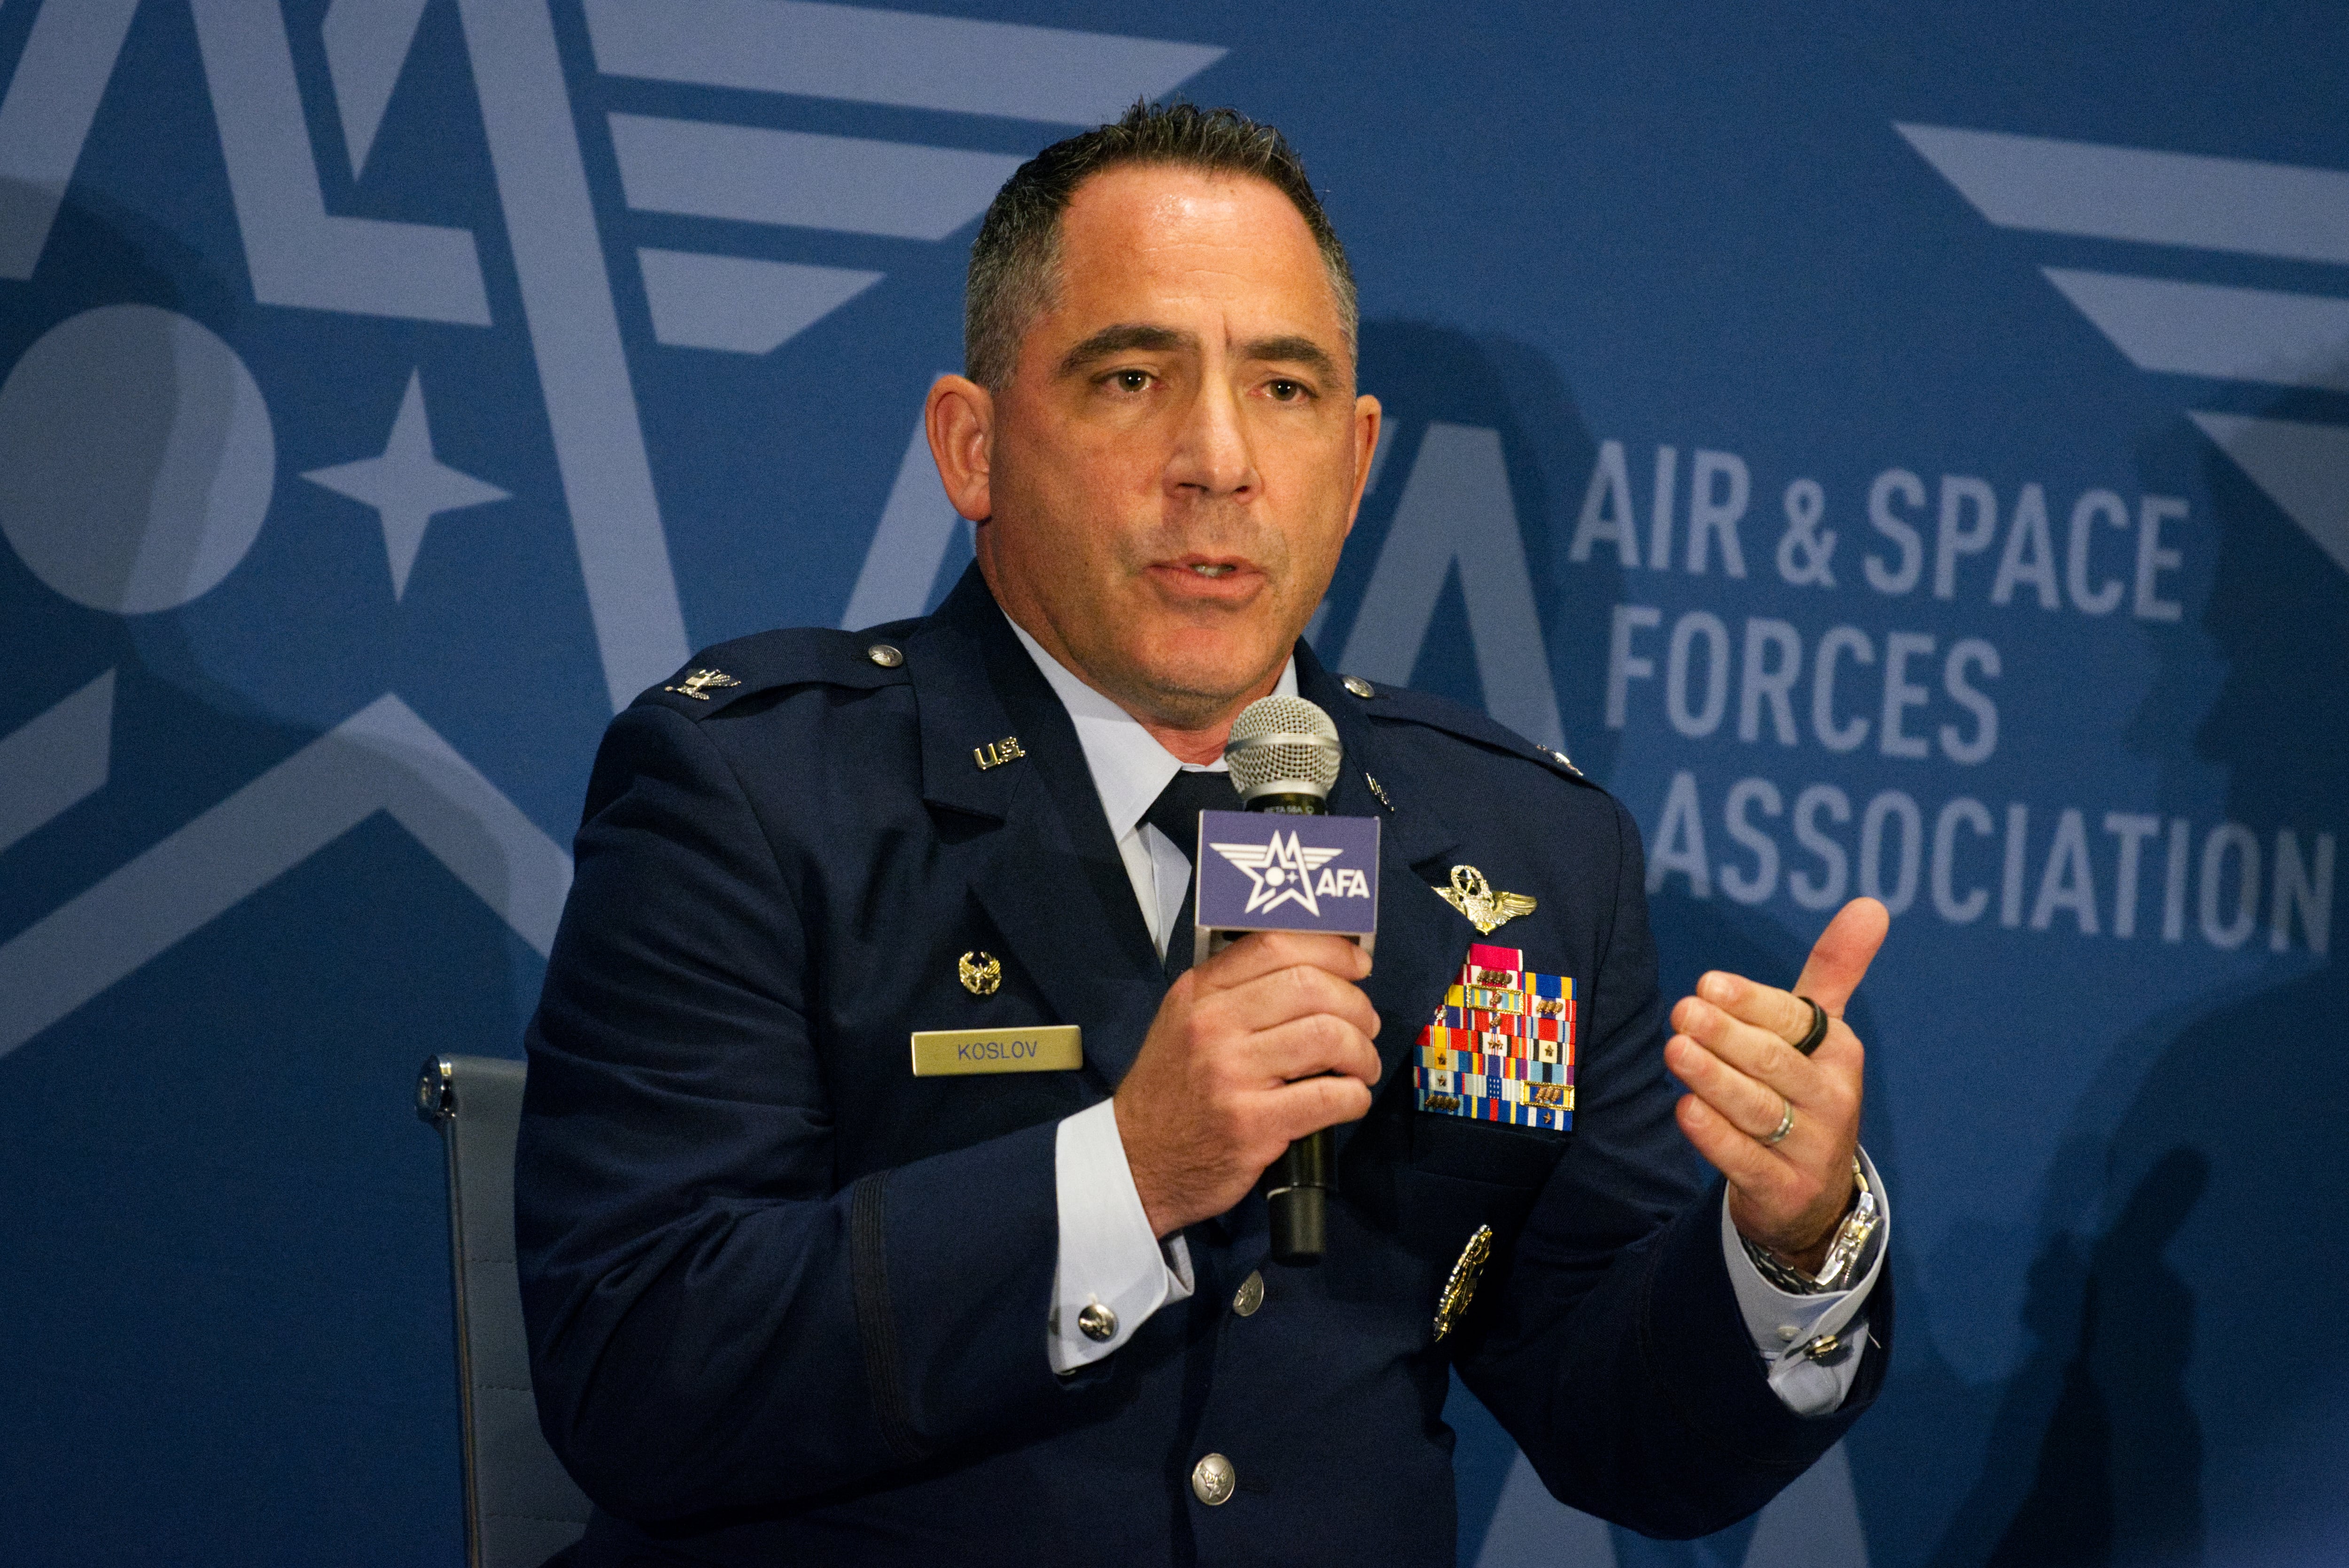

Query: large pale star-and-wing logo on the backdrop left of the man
[0,0,1224,1054]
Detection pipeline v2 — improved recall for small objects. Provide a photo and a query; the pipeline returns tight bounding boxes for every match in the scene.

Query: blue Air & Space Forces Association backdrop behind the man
[0,0,2349,1568]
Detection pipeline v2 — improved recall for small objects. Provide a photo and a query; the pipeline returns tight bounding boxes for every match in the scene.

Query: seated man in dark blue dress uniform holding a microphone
[517,108,1891,1566]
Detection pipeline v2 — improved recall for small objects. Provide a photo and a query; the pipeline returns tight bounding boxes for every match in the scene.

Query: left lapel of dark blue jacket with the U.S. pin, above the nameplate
[907,566,1165,1089]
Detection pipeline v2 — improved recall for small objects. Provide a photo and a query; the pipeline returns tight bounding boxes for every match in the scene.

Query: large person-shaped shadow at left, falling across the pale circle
[0,180,538,1563]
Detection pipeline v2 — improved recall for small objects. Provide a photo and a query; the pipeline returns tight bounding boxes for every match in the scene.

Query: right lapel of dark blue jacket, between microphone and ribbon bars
[1297,643,1475,1087]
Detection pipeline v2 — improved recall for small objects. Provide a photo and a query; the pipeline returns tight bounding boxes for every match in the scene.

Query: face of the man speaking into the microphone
[949,167,1379,728]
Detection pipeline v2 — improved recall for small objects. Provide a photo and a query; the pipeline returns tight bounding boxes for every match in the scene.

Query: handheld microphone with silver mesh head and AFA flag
[1193,697,1379,1263]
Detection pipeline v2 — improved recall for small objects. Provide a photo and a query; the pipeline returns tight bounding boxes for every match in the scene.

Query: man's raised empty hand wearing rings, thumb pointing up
[1663,899,1891,1272]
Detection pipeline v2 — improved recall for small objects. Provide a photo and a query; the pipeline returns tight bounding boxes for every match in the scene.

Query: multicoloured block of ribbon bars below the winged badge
[1412,944,1574,1132]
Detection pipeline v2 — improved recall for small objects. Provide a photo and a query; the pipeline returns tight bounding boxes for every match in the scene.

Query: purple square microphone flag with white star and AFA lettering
[1191,812,1379,958]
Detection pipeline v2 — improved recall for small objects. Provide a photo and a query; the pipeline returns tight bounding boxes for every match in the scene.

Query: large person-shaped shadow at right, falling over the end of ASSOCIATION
[1924,380,2349,1568]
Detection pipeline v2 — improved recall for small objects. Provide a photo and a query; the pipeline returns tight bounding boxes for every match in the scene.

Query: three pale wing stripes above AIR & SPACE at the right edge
[1893,124,2349,570]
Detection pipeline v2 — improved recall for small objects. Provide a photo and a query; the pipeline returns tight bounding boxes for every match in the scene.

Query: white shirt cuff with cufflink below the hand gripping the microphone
[1045,1101,1193,1373]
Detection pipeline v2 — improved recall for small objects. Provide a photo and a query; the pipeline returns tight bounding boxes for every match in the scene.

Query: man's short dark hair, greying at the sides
[963,101,1360,392]
